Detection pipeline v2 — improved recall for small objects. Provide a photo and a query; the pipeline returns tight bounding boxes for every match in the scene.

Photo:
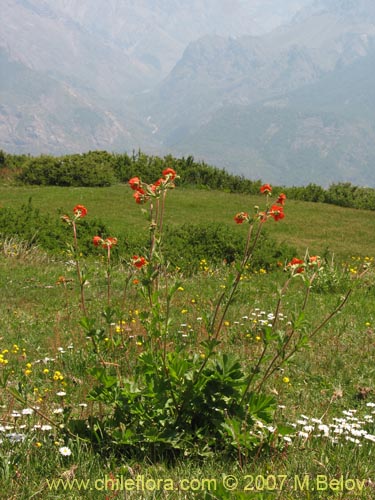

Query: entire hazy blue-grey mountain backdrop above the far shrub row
[0,0,375,187]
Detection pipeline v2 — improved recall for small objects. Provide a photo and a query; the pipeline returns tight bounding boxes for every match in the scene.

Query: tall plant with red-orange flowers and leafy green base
[70,178,349,462]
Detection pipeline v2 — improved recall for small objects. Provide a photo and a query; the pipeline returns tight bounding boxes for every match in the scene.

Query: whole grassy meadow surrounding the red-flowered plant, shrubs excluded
[0,186,375,500]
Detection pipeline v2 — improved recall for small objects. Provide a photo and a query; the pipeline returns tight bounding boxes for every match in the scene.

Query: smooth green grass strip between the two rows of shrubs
[0,185,375,259]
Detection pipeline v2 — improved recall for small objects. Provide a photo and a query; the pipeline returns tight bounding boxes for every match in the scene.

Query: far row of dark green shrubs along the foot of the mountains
[0,150,375,210]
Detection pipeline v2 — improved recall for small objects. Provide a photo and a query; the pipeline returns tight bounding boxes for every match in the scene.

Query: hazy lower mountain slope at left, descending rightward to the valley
[0,50,143,154]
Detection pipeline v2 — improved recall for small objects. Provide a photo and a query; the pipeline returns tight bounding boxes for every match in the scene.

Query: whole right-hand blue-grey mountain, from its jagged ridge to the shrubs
[138,0,375,186]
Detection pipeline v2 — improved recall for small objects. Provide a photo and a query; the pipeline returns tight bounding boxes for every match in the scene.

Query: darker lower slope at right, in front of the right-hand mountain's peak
[174,41,375,186]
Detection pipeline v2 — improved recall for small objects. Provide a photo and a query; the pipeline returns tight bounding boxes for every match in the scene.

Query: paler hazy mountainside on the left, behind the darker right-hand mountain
[0,0,307,154]
